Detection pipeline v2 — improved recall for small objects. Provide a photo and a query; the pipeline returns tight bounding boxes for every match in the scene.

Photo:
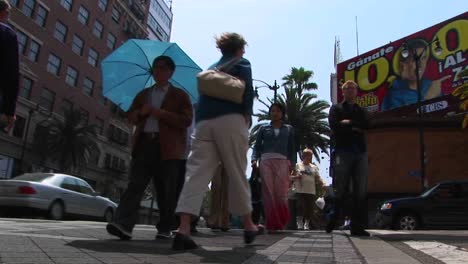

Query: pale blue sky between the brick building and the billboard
[171,0,468,183]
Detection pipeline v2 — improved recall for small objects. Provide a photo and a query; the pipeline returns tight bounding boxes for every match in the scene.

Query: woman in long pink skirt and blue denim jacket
[252,103,296,233]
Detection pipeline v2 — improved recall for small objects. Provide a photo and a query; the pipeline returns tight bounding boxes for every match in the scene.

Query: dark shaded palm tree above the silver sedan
[35,110,99,172]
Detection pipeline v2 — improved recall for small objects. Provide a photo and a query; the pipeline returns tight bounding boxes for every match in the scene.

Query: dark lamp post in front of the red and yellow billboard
[401,38,442,191]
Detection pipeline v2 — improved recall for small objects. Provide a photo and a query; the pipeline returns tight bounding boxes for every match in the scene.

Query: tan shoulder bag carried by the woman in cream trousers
[197,58,245,104]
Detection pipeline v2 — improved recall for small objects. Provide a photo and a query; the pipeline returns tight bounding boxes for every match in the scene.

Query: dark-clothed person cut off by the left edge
[0,0,19,133]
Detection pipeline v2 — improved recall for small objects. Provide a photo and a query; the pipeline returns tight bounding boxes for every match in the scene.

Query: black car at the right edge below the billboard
[376,180,468,230]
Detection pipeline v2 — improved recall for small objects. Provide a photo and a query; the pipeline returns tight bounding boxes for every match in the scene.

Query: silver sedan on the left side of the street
[0,173,117,222]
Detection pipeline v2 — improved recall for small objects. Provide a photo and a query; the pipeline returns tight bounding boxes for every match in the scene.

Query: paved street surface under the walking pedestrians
[0,218,468,264]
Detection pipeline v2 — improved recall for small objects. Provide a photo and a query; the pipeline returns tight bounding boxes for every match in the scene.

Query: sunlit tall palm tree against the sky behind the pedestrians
[249,67,330,162]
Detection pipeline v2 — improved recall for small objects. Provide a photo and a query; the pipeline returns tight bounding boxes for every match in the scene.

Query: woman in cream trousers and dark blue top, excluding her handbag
[172,33,257,250]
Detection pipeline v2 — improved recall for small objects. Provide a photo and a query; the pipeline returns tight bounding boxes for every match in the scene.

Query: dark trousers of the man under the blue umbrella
[114,134,185,232]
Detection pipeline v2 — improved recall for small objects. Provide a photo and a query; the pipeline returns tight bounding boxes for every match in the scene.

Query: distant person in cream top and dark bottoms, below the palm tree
[293,148,320,230]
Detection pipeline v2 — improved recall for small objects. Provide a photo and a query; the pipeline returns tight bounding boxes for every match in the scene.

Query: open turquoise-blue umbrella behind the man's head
[101,39,201,111]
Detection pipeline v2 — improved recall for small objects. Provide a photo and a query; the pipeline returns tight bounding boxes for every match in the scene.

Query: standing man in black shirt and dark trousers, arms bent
[326,81,369,236]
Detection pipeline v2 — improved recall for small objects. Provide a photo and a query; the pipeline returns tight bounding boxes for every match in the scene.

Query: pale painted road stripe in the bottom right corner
[404,241,468,264]
